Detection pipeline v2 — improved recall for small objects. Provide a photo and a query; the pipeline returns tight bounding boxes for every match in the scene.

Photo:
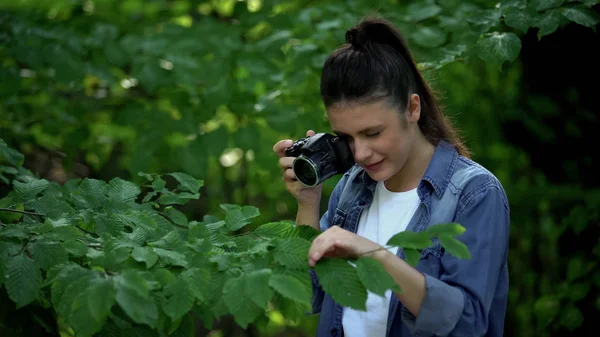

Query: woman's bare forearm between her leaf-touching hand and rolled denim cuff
[372,249,425,317]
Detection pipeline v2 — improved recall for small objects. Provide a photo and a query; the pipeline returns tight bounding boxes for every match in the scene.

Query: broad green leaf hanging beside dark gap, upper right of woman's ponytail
[477,32,521,68]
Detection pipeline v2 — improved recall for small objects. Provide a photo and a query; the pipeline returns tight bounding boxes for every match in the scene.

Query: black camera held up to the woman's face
[285,133,354,187]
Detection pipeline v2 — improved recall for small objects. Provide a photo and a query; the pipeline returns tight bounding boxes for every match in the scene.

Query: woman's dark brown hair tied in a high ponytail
[321,18,470,157]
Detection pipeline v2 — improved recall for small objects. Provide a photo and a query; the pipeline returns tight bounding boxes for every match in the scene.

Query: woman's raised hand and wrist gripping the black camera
[273,130,323,207]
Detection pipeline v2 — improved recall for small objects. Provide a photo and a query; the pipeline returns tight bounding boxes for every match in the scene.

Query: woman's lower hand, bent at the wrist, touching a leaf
[308,226,383,267]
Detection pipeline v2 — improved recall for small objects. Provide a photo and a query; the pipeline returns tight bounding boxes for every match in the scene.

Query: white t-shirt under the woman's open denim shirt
[342,182,420,337]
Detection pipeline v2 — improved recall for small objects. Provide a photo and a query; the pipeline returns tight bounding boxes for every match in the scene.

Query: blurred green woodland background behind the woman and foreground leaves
[0,0,600,337]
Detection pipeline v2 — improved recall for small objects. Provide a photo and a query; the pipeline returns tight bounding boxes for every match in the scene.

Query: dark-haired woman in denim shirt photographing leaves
[274,19,510,337]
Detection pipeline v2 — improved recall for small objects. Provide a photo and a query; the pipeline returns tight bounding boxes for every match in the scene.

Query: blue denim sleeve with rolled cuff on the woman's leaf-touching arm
[402,182,510,336]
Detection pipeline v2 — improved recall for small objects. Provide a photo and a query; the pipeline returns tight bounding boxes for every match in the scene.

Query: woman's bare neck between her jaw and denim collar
[385,133,435,192]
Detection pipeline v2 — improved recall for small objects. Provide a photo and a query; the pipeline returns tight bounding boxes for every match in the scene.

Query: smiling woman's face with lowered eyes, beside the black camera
[327,99,418,181]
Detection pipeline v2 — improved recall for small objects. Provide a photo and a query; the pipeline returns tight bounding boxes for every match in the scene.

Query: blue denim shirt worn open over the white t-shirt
[311,141,510,337]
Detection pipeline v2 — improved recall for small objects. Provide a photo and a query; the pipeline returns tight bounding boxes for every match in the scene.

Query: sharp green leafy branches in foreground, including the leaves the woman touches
[0,138,462,336]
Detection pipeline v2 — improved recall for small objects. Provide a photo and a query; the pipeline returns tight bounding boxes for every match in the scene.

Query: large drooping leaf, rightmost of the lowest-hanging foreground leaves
[223,275,268,329]
